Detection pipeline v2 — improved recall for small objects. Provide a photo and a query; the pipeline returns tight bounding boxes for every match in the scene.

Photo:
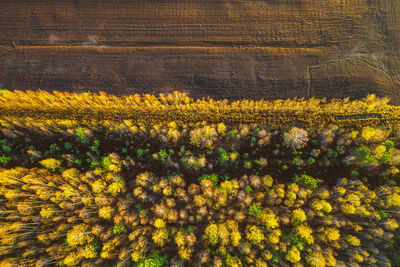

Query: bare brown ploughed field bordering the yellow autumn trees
[0,0,400,104]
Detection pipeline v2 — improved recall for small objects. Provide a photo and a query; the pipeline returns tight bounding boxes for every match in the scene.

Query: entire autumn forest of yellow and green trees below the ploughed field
[0,90,400,267]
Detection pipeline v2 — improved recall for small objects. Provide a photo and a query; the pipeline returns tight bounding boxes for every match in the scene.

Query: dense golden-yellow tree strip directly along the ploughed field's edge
[0,90,400,127]
